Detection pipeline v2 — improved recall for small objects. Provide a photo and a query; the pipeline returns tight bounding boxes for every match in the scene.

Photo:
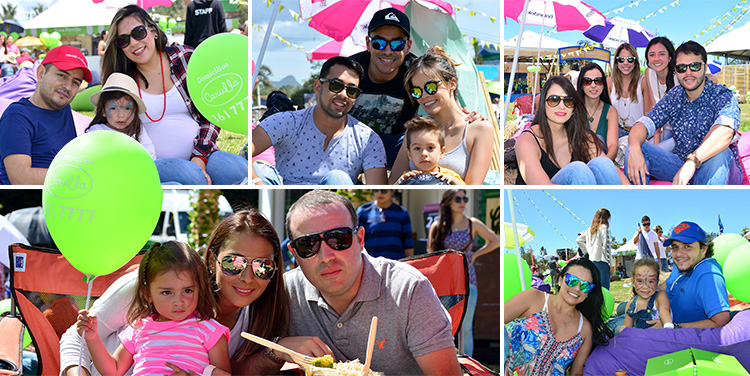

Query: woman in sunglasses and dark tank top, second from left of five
[577,63,619,161]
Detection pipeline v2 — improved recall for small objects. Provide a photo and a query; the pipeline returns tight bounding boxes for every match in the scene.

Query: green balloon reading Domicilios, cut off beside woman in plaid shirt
[187,33,250,134]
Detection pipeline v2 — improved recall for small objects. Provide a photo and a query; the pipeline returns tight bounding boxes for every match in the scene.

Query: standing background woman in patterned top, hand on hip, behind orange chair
[427,189,500,356]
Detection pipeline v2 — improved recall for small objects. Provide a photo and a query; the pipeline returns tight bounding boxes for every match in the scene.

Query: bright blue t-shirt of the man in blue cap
[667,257,729,323]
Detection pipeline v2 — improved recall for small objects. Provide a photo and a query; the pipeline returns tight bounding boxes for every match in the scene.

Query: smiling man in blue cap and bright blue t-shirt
[664,222,729,328]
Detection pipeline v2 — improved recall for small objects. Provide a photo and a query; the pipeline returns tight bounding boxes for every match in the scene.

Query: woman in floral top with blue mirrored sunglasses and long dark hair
[504,258,612,376]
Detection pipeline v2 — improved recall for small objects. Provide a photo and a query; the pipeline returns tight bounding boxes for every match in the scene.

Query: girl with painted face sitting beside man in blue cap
[620,257,674,331]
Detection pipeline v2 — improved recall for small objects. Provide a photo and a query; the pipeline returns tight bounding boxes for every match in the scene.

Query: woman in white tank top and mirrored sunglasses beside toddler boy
[389,46,494,184]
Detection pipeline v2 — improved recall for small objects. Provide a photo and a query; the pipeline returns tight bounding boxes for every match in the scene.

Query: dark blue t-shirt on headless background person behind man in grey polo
[357,201,414,260]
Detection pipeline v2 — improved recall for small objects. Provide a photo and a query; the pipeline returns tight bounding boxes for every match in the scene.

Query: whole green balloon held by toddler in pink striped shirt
[42,131,162,275]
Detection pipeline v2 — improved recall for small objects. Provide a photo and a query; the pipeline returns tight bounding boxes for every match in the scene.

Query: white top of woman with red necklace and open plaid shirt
[139,86,199,160]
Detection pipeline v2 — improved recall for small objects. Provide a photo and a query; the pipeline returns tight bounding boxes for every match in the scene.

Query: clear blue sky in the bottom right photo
[503,188,750,258]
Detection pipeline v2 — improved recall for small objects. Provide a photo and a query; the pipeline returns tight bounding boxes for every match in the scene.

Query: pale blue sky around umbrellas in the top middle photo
[251,0,502,83]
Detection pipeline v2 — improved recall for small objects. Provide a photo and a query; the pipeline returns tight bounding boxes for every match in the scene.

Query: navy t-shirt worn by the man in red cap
[0,98,76,184]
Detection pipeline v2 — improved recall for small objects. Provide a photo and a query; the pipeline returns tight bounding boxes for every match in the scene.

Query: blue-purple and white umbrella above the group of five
[583,17,655,48]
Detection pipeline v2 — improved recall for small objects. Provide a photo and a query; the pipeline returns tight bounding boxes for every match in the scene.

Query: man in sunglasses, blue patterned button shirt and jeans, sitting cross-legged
[625,41,742,185]
